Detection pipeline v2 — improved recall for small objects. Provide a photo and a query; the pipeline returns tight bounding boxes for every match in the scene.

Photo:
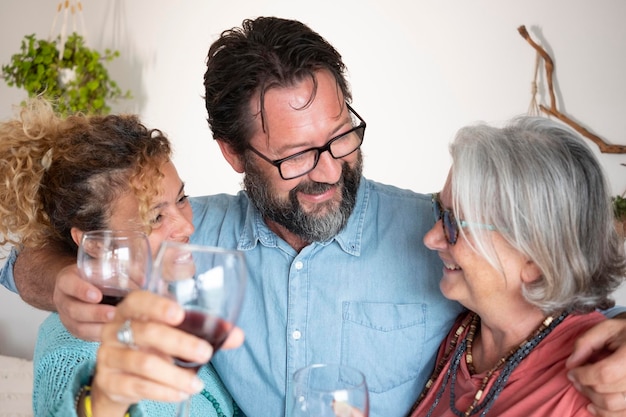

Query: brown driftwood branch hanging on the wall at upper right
[517,25,626,154]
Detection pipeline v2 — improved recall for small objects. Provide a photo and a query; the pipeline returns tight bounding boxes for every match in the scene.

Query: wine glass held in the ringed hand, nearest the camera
[151,242,247,417]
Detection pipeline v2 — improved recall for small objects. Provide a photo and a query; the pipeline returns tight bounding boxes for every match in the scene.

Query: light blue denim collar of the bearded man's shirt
[237,177,370,256]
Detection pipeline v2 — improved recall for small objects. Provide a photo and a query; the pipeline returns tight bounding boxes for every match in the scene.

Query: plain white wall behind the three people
[0,0,626,356]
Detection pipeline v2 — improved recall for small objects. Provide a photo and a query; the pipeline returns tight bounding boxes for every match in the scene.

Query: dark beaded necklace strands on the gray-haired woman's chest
[409,312,567,417]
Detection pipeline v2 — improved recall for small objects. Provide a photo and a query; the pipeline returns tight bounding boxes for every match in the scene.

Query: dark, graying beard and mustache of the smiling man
[243,151,363,242]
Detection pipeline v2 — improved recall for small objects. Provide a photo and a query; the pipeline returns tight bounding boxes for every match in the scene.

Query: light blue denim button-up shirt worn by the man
[192,179,461,417]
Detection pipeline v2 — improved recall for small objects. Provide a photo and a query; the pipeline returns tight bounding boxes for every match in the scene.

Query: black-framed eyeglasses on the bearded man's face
[248,103,366,180]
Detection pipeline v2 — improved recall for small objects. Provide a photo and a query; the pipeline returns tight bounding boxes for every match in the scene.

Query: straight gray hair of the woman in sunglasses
[450,117,626,313]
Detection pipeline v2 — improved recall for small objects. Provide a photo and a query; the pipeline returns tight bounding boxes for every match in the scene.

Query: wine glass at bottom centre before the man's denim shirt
[291,364,369,417]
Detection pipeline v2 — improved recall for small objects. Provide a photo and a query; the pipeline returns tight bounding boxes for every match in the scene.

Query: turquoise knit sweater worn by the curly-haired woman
[33,313,243,417]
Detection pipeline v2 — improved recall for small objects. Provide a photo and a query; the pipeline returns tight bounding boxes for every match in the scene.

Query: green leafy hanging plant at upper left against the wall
[2,33,130,114]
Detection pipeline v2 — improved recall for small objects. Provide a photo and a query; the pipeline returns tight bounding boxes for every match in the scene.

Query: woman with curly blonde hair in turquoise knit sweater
[0,99,236,417]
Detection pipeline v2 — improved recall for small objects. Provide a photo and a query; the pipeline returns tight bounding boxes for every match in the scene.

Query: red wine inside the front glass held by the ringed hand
[175,309,232,370]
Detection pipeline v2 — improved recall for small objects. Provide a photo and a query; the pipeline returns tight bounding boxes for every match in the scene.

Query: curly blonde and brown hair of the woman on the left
[0,98,171,252]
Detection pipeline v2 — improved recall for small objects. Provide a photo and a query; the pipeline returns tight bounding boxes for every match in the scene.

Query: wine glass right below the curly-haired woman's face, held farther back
[76,230,152,306]
